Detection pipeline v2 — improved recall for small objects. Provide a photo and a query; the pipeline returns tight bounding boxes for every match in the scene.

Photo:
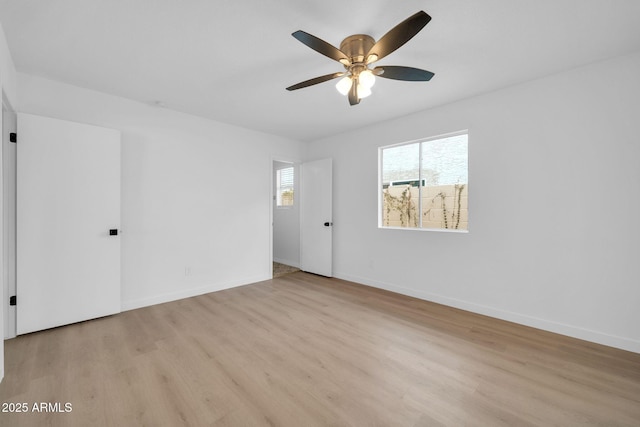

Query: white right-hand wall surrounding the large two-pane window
[306,53,640,352]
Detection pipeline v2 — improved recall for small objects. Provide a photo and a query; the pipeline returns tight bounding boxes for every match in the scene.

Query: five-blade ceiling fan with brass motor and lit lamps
[287,11,434,105]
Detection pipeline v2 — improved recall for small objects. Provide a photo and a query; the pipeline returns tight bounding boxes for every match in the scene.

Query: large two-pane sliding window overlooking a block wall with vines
[380,131,469,231]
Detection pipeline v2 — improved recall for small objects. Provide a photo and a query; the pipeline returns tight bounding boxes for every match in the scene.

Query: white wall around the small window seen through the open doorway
[273,161,300,267]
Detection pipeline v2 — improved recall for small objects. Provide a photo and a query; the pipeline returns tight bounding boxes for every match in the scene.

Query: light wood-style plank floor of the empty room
[0,272,640,427]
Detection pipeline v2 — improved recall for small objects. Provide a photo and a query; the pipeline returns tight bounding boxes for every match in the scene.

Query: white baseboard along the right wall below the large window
[334,272,640,353]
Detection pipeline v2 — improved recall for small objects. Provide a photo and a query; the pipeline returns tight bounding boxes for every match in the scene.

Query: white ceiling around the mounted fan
[0,0,640,141]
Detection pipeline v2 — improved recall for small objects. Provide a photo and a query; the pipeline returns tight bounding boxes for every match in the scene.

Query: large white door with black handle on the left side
[16,114,120,334]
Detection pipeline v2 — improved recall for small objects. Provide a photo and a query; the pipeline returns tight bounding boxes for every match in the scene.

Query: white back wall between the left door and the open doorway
[18,73,300,310]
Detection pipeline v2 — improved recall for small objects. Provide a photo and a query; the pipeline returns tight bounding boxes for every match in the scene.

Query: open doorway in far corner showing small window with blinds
[272,160,300,277]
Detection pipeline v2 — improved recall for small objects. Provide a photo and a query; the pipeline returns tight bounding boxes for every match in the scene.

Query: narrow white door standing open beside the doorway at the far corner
[300,159,333,277]
